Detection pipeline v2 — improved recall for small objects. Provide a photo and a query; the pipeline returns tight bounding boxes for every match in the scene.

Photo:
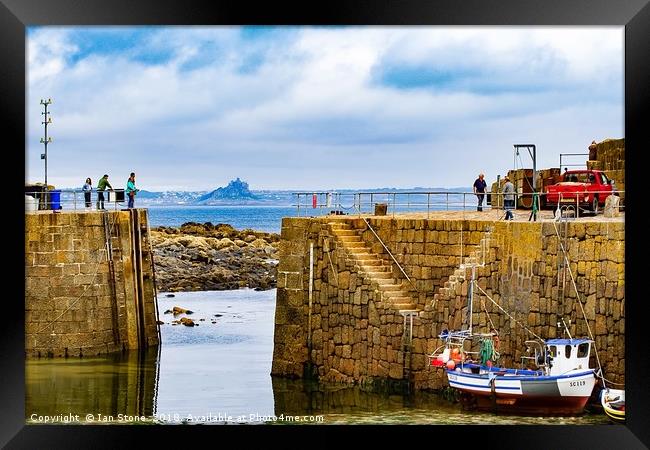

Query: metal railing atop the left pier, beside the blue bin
[25,189,127,212]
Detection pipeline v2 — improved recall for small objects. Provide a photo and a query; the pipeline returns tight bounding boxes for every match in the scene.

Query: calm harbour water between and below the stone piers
[25,289,608,424]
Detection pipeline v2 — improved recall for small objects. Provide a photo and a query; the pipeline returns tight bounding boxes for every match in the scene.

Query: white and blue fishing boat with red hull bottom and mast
[429,256,596,415]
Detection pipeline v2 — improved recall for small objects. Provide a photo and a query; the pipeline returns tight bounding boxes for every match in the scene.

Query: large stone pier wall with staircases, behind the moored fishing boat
[272,217,625,389]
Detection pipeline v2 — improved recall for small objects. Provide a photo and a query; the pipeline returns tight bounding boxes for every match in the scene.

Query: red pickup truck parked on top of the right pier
[546,170,616,213]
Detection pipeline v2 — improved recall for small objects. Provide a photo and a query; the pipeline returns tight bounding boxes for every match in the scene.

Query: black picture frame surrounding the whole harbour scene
[0,0,650,449]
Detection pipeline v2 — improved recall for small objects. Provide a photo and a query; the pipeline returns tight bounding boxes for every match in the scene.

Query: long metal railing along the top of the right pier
[292,190,625,218]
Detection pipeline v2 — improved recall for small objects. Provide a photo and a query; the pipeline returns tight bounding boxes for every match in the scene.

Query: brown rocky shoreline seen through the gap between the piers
[151,222,280,292]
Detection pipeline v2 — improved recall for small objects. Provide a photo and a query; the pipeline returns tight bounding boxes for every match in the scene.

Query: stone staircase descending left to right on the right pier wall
[328,222,417,310]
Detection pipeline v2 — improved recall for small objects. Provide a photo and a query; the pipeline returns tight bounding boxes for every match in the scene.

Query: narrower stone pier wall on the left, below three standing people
[25,209,159,357]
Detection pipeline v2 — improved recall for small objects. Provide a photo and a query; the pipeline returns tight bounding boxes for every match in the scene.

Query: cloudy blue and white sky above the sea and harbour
[25,26,624,191]
